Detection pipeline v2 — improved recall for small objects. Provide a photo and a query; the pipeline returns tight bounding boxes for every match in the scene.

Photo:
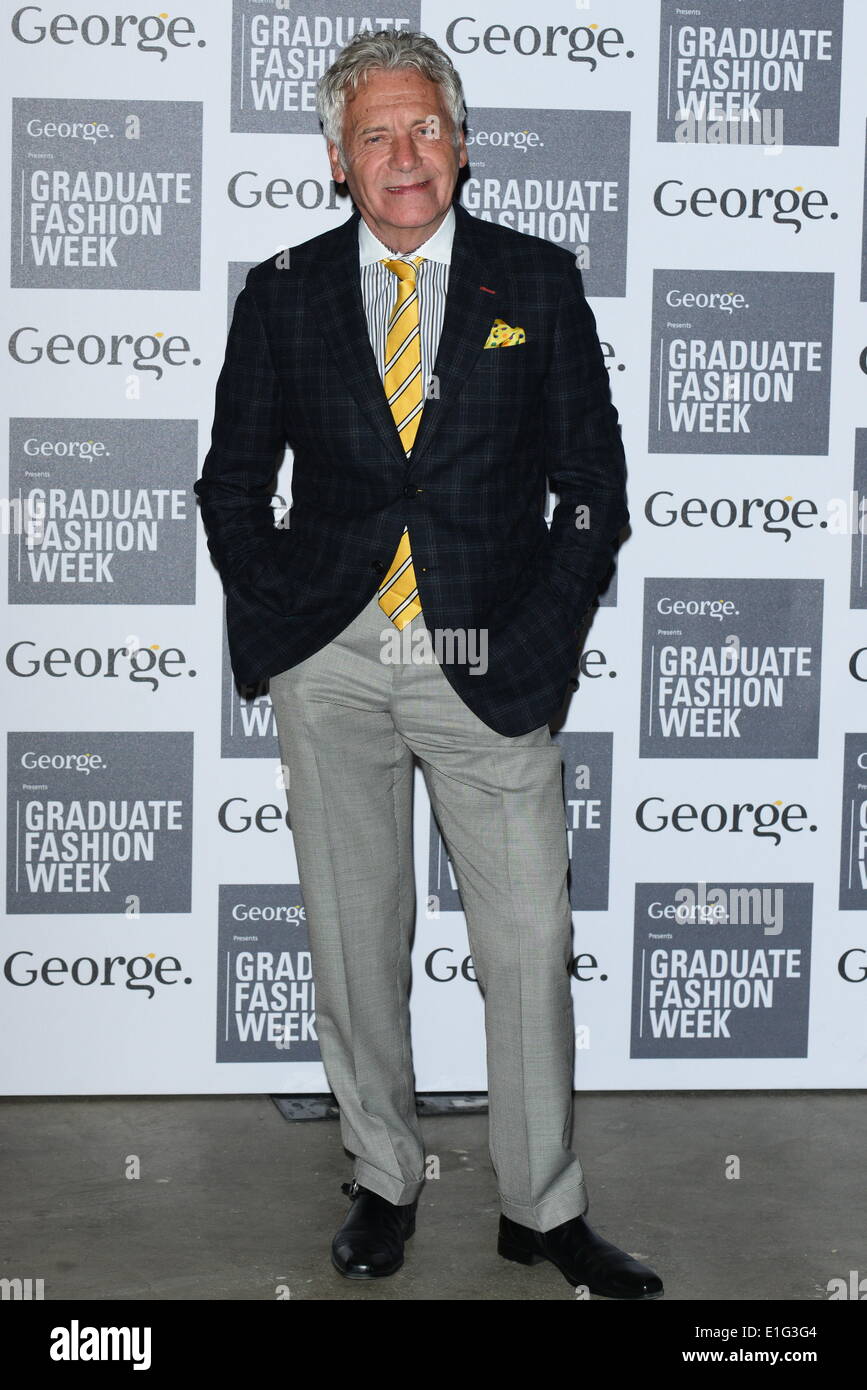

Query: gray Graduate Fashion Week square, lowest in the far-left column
[6,730,193,917]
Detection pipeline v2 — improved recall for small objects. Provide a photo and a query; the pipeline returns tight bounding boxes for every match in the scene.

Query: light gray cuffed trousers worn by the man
[271,596,588,1230]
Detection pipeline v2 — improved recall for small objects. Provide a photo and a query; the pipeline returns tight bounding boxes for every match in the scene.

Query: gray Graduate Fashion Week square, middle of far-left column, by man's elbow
[8,418,197,603]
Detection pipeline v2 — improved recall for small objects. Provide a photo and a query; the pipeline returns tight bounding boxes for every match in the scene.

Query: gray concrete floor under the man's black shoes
[0,1091,867,1301]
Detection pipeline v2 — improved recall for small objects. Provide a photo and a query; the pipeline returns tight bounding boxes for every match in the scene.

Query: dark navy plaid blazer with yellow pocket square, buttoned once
[195,203,628,735]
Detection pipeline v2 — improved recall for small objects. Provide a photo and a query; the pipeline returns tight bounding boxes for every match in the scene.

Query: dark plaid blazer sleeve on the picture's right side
[543,261,629,624]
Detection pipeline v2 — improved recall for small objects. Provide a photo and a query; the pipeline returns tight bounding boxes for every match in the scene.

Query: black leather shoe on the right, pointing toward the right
[497,1215,663,1298]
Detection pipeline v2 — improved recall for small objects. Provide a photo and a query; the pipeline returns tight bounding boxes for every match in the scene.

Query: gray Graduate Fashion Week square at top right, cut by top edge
[657,0,843,145]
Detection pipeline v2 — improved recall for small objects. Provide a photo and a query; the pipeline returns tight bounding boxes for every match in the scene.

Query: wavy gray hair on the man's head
[317,29,467,167]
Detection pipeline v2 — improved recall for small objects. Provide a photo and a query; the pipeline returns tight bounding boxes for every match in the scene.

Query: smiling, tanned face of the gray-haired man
[328,68,467,252]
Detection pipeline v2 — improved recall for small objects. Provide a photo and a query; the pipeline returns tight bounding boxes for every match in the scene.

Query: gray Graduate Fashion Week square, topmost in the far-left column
[11,97,201,289]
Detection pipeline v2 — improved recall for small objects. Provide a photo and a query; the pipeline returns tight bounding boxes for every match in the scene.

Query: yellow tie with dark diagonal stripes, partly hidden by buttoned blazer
[378,256,424,628]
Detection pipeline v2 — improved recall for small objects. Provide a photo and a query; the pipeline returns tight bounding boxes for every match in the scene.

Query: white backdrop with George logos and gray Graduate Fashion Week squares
[0,0,867,1094]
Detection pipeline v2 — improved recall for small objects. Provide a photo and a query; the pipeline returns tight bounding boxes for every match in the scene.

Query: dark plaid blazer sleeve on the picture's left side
[193,275,286,585]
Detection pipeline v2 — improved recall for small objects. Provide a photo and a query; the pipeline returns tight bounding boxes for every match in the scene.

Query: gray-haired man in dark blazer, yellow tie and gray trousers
[196,24,663,1298]
